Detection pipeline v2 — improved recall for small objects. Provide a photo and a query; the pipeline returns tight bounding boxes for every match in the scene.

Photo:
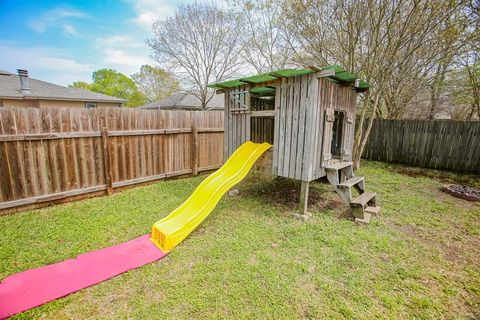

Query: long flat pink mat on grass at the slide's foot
[0,234,166,319]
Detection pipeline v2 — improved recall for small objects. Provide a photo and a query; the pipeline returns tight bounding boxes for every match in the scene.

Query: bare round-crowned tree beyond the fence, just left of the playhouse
[147,3,240,108]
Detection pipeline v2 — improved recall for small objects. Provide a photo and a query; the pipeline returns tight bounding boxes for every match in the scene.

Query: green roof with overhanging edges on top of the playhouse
[209,65,369,93]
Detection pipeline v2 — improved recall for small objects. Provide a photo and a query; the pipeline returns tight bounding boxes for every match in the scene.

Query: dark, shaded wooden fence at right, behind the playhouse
[363,120,480,173]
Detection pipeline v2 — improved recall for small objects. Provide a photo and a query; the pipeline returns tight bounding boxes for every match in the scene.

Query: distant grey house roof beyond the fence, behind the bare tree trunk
[140,93,225,110]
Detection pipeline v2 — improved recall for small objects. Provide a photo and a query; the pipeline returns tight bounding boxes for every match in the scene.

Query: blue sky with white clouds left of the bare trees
[0,0,219,85]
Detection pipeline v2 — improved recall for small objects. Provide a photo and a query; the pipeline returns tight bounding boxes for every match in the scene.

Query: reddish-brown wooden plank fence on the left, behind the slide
[0,108,224,213]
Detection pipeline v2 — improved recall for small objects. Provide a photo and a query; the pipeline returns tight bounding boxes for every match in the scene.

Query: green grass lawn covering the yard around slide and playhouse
[0,162,480,319]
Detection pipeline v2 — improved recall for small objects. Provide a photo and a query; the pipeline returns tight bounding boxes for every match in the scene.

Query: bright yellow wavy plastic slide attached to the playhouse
[151,141,271,252]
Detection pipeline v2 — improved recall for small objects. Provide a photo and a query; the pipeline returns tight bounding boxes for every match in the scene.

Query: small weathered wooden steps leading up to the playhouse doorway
[326,162,380,224]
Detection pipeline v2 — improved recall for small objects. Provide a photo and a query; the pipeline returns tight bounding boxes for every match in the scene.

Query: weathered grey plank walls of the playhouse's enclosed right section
[273,75,356,181]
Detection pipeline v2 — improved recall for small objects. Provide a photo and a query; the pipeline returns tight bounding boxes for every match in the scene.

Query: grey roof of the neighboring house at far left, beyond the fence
[0,70,127,103]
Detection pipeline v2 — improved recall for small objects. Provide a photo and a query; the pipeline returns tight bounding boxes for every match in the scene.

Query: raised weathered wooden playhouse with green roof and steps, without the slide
[211,66,379,223]
